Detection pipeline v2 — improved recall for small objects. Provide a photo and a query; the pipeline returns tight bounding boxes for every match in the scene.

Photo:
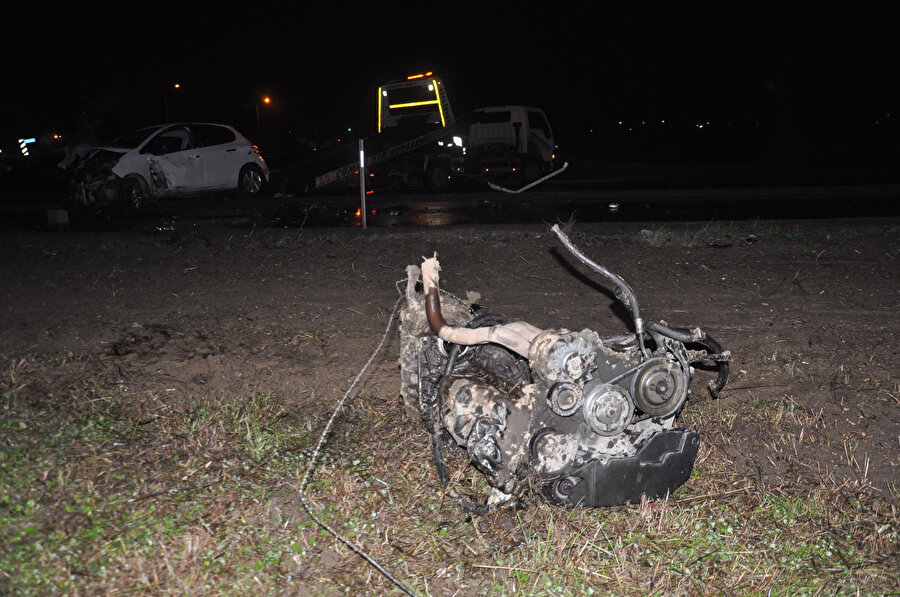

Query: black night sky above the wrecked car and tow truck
[0,2,900,161]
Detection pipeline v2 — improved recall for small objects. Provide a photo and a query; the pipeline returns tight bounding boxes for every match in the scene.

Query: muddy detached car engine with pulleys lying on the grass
[400,226,731,511]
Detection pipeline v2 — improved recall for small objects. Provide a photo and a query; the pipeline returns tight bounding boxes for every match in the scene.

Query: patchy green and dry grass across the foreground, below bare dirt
[0,344,900,596]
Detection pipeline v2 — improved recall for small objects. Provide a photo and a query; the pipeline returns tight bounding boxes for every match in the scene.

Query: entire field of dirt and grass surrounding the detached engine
[0,218,900,595]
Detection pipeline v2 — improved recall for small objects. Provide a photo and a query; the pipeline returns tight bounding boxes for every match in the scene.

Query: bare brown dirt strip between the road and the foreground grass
[0,214,900,502]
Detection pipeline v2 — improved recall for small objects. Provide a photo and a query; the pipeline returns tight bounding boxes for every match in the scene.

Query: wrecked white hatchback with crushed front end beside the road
[59,123,269,210]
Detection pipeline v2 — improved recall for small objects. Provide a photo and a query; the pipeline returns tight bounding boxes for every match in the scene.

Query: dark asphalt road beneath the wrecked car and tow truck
[0,165,900,230]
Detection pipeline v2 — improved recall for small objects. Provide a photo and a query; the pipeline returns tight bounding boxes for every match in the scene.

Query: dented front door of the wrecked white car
[141,125,207,195]
